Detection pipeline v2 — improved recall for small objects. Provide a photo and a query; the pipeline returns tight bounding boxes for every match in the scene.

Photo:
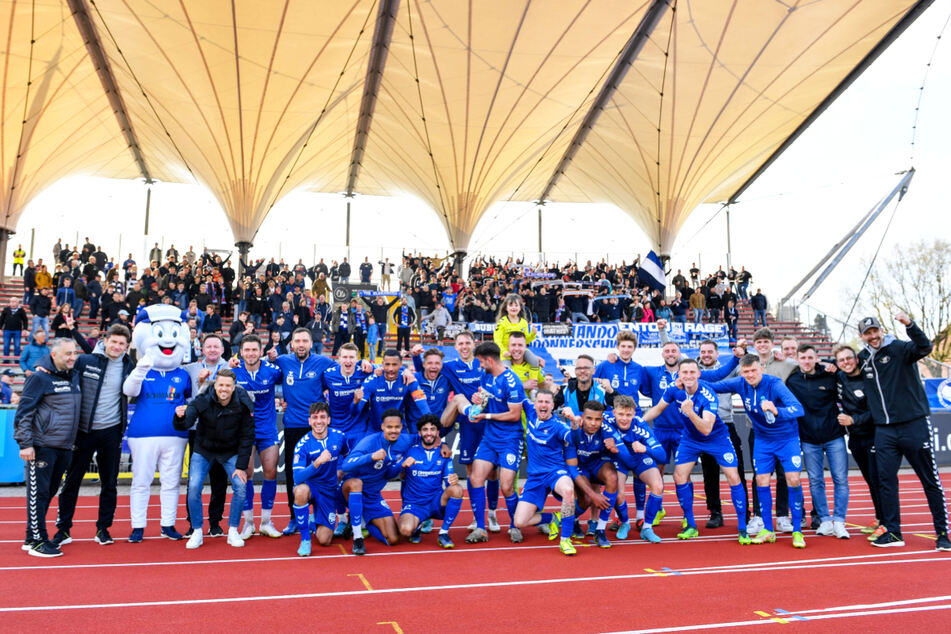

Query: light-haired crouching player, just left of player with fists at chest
[605,395,667,544]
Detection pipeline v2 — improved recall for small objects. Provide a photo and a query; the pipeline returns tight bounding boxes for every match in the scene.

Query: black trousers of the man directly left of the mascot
[56,423,122,531]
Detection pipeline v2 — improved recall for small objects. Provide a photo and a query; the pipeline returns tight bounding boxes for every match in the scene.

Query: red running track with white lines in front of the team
[0,475,951,633]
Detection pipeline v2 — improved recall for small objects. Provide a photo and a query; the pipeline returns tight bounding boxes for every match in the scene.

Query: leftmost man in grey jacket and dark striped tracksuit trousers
[13,339,81,557]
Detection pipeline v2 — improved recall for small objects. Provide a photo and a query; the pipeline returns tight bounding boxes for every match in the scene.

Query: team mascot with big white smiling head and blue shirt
[122,304,191,542]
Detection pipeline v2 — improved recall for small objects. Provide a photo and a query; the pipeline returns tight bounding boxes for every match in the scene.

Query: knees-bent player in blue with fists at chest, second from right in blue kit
[644,359,751,544]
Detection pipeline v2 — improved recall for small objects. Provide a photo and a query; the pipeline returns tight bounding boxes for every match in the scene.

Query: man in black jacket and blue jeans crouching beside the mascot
[173,368,254,549]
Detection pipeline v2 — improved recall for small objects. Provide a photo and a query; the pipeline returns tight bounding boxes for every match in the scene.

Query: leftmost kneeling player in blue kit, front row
[294,402,347,557]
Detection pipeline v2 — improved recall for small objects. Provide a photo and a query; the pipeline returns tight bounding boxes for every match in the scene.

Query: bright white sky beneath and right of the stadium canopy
[16,0,951,330]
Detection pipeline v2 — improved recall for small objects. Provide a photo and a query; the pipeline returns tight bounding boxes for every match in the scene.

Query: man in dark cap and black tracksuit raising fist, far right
[859,312,951,551]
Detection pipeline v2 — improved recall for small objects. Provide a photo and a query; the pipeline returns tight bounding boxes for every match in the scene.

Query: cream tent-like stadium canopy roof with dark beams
[0,0,930,253]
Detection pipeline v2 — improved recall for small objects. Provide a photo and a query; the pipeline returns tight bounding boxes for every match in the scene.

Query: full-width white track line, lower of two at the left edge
[0,551,948,613]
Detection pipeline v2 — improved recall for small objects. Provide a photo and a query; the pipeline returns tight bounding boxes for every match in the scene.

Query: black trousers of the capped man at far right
[875,418,948,535]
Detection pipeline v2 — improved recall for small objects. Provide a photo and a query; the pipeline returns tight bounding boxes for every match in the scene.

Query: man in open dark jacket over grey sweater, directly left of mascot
[53,324,135,546]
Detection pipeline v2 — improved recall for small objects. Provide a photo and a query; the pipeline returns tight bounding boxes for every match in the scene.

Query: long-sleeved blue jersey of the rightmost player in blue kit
[710,374,804,439]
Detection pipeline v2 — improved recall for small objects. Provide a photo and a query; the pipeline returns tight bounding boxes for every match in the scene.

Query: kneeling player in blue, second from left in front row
[341,408,417,555]
